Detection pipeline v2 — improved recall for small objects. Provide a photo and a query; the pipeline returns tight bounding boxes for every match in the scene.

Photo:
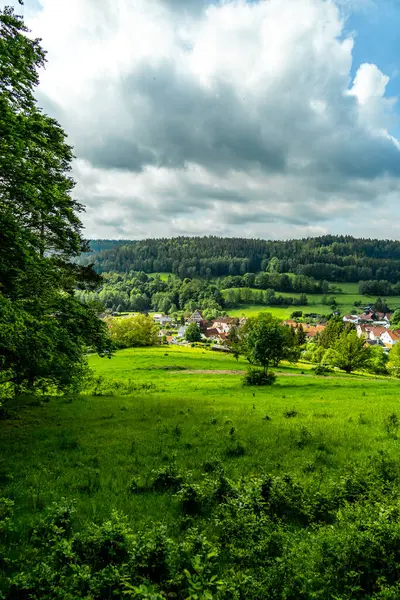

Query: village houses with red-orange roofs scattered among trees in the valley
[113,306,400,352]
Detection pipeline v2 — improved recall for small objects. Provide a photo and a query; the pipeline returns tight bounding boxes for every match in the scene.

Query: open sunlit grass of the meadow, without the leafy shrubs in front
[0,347,400,529]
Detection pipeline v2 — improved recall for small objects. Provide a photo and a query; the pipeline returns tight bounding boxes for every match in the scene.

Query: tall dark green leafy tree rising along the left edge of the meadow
[0,7,110,391]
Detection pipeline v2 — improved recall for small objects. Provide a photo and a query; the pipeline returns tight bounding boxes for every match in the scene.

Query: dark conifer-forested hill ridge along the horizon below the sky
[80,235,400,283]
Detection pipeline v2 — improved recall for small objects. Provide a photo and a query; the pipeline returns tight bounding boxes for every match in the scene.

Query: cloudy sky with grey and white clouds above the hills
[6,0,400,239]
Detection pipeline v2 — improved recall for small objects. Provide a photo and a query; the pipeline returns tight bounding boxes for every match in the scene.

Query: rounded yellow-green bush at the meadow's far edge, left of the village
[106,314,159,348]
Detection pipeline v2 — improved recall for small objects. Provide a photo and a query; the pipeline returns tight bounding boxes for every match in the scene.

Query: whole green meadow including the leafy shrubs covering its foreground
[0,347,400,600]
